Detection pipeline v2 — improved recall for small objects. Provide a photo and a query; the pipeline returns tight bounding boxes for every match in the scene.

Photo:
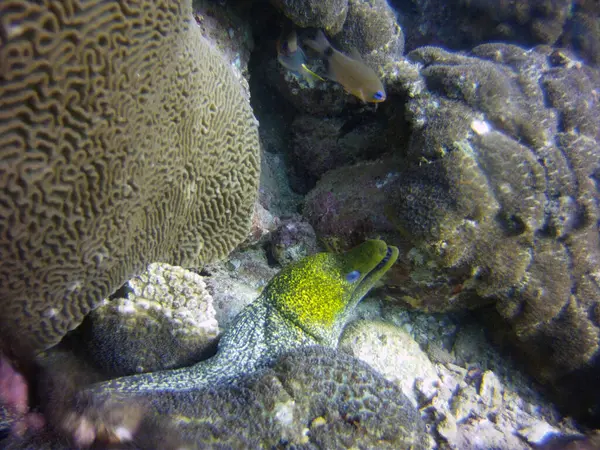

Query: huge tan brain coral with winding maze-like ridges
[0,0,259,351]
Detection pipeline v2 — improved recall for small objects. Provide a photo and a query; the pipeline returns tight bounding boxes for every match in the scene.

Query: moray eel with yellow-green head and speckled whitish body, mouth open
[87,240,398,397]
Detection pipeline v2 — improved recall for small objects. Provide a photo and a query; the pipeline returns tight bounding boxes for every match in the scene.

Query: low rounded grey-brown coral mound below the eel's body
[4,346,426,450]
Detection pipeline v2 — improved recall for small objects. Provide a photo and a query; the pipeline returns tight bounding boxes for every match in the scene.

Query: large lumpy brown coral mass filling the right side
[388,44,600,390]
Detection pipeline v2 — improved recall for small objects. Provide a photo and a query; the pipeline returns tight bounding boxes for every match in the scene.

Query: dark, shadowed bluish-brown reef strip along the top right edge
[391,0,600,65]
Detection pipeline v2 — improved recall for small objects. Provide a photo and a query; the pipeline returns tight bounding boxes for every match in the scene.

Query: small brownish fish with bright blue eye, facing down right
[305,30,386,103]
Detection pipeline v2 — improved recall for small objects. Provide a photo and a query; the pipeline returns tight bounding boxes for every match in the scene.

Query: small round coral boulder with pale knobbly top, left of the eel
[83,263,219,376]
